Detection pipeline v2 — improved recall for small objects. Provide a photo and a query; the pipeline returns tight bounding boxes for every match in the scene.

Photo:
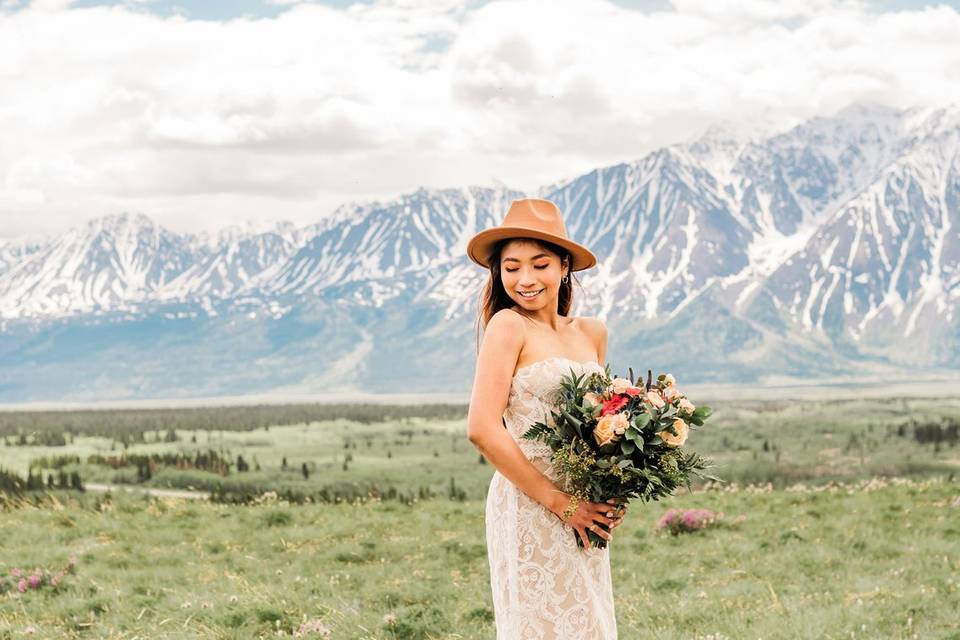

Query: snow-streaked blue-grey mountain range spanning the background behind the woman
[0,105,960,399]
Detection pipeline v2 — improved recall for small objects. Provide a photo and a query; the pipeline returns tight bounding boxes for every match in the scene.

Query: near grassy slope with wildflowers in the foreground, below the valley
[0,479,960,639]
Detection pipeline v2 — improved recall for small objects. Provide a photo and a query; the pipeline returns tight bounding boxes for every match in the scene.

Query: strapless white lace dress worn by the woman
[486,357,617,640]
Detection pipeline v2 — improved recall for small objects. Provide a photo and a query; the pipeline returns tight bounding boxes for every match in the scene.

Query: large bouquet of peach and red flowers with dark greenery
[522,365,722,548]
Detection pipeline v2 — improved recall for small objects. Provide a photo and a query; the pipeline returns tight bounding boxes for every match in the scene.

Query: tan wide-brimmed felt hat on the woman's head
[467,198,597,271]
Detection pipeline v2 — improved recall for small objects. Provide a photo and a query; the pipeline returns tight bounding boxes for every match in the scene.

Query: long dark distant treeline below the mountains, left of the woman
[0,404,467,444]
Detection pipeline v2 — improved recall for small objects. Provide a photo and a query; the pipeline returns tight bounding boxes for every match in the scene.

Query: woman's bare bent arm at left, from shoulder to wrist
[467,309,570,516]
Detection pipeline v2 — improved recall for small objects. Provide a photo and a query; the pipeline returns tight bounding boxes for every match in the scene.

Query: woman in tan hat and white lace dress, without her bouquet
[467,198,625,640]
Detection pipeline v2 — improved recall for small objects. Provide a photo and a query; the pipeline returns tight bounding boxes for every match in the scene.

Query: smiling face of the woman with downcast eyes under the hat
[500,240,568,311]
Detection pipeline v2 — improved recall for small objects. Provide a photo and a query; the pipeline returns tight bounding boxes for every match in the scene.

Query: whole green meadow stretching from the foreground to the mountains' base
[0,398,960,640]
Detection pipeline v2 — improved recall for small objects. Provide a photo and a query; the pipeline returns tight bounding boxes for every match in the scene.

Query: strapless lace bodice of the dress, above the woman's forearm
[503,356,604,460]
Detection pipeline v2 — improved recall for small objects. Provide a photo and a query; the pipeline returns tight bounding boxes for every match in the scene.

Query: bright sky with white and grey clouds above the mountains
[0,0,960,237]
